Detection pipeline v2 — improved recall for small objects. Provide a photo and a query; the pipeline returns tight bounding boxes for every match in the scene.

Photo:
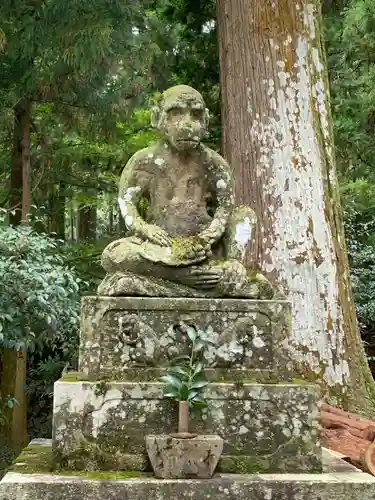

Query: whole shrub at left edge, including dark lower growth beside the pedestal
[0,212,82,437]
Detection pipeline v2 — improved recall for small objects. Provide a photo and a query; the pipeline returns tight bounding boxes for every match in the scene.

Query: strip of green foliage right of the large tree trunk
[325,0,375,373]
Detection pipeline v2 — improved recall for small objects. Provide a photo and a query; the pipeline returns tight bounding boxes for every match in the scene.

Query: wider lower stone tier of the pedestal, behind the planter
[53,381,321,472]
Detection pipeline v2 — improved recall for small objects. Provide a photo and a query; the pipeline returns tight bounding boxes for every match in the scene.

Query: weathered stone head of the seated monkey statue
[152,85,209,151]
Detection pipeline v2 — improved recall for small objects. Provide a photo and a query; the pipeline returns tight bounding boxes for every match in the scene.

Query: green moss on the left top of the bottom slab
[10,445,146,480]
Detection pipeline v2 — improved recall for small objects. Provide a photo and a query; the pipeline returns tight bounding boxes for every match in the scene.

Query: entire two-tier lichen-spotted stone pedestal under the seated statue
[53,297,321,473]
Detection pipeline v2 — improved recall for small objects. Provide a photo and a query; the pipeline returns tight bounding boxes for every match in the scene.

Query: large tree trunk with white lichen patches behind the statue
[217,0,375,412]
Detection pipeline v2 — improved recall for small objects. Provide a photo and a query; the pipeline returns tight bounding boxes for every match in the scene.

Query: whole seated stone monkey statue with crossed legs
[98,85,273,298]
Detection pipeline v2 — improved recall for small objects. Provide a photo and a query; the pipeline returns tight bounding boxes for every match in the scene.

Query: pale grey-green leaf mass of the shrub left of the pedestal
[0,209,79,352]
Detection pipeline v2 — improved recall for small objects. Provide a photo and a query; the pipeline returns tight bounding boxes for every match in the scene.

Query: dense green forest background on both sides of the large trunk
[0,0,375,469]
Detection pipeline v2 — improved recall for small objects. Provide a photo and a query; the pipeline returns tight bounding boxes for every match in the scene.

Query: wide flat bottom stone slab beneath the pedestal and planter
[0,453,375,500]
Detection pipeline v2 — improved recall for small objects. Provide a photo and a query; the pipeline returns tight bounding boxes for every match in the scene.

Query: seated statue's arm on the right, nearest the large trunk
[200,148,234,245]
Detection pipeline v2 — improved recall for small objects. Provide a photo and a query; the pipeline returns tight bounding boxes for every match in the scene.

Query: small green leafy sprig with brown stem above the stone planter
[160,326,213,435]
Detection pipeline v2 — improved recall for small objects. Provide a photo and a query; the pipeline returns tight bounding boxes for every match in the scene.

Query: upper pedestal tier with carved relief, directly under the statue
[79,297,292,380]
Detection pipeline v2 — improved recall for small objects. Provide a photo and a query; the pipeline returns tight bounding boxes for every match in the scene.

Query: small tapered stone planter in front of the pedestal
[145,435,223,479]
